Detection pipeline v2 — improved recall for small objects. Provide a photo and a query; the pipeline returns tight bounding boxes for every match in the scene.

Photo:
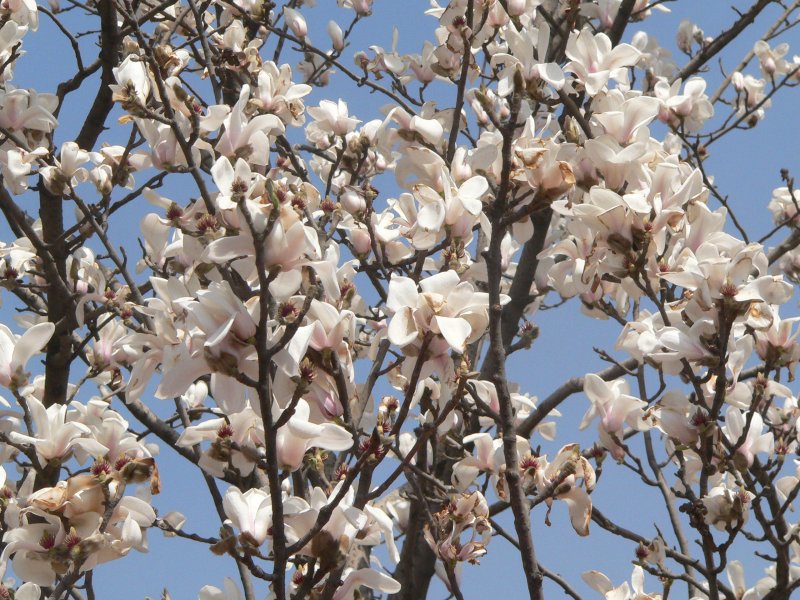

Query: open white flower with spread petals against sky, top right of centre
[564,28,641,96]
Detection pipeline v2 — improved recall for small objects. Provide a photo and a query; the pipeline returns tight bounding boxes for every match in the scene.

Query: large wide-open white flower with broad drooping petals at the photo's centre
[386,271,500,353]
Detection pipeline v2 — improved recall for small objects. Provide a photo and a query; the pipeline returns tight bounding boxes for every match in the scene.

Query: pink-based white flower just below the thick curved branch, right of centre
[579,373,647,460]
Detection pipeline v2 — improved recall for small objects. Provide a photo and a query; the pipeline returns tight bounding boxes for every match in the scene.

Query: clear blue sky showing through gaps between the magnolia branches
[3,0,800,600]
